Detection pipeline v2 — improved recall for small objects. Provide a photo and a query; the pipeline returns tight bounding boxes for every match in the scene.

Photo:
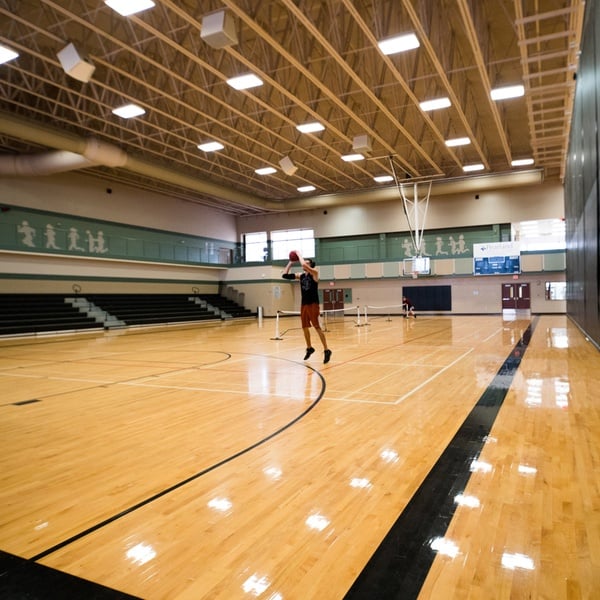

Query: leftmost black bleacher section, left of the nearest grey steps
[0,294,103,335]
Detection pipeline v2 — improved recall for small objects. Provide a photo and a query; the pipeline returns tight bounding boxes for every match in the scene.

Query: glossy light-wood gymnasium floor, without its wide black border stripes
[0,315,600,600]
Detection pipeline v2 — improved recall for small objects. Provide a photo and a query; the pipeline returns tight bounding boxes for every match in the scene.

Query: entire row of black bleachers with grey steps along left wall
[0,294,256,336]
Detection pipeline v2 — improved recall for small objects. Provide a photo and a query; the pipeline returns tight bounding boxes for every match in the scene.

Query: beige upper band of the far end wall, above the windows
[238,183,564,238]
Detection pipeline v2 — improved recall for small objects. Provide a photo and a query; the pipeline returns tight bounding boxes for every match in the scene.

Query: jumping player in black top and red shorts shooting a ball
[282,251,331,364]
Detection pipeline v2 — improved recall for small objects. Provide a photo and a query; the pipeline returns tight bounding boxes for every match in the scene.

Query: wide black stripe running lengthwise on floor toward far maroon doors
[345,319,537,600]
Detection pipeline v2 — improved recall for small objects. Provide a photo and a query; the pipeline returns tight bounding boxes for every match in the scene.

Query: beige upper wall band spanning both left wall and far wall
[0,173,564,247]
